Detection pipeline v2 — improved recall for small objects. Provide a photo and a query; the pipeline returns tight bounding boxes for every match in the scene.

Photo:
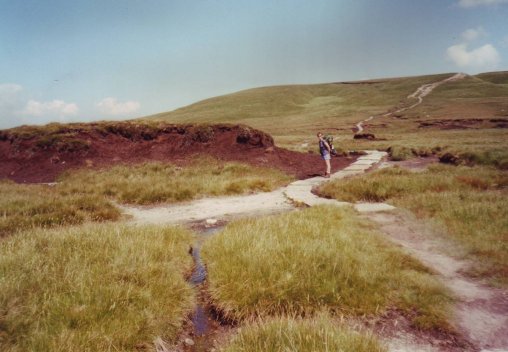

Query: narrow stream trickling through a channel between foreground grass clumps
[189,225,224,352]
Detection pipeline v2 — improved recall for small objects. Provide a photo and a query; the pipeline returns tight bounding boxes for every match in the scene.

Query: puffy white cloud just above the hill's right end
[446,44,501,69]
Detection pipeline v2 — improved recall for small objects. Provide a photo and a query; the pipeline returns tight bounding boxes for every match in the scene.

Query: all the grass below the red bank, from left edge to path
[0,158,292,237]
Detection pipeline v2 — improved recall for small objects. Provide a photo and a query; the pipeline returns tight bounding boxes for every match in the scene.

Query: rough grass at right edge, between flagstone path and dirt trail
[319,165,508,285]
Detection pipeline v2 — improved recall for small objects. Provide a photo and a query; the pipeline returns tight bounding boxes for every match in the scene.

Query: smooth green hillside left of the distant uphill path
[147,74,452,147]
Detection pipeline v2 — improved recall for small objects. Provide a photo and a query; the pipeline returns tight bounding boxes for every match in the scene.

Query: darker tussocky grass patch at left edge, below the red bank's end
[0,181,120,237]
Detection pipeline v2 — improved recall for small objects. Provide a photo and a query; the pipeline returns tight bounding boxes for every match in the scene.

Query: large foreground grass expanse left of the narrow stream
[0,225,194,352]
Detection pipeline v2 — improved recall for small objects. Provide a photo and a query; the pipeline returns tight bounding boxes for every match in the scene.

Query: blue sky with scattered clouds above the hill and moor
[0,0,508,129]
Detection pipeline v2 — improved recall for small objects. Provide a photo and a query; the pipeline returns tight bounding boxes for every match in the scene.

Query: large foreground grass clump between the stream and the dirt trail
[202,207,449,328]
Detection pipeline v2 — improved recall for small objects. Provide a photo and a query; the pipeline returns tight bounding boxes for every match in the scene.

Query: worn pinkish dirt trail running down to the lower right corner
[363,212,508,351]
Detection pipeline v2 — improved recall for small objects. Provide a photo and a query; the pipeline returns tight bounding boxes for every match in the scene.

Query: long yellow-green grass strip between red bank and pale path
[57,158,291,204]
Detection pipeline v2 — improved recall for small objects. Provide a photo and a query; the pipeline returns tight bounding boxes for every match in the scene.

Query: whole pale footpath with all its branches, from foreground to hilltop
[118,73,508,352]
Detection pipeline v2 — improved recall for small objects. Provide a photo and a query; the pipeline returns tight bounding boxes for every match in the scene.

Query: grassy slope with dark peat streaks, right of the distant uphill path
[345,73,508,165]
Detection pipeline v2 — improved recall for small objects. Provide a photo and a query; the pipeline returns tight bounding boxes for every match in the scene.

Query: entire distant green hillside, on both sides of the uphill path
[143,72,508,163]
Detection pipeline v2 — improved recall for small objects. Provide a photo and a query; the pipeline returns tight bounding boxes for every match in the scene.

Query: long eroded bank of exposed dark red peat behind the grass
[0,122,353,183]
